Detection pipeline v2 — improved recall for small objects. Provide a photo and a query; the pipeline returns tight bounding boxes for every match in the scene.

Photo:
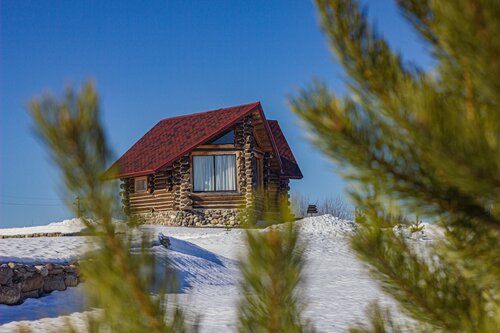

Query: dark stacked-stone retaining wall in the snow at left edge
[0,263,81,305]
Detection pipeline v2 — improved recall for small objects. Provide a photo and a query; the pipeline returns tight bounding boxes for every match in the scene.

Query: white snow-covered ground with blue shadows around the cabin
[0,215,437,332]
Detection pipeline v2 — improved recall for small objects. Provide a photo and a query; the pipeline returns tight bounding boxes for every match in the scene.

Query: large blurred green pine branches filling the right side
[292,0,500,332]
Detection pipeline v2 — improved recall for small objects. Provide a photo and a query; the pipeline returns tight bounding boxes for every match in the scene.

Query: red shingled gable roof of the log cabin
[114,102,302,178]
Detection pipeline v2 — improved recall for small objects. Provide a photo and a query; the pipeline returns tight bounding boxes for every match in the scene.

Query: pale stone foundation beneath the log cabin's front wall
[135,209,244,227]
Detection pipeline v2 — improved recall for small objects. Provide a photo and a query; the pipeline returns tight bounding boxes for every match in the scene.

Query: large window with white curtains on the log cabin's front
[193,155,236,192]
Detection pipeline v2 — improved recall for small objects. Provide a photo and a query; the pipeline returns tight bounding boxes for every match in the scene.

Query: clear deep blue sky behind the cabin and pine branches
[0,0,429,227]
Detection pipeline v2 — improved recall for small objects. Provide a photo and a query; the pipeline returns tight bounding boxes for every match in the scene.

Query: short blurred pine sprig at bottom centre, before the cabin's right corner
[239,218,311,333]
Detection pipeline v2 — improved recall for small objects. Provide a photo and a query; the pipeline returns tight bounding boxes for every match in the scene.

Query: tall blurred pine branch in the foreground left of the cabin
[30,83,189,332]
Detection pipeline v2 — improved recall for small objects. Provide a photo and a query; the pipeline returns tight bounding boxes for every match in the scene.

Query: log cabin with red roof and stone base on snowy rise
[111,102,302,227]
